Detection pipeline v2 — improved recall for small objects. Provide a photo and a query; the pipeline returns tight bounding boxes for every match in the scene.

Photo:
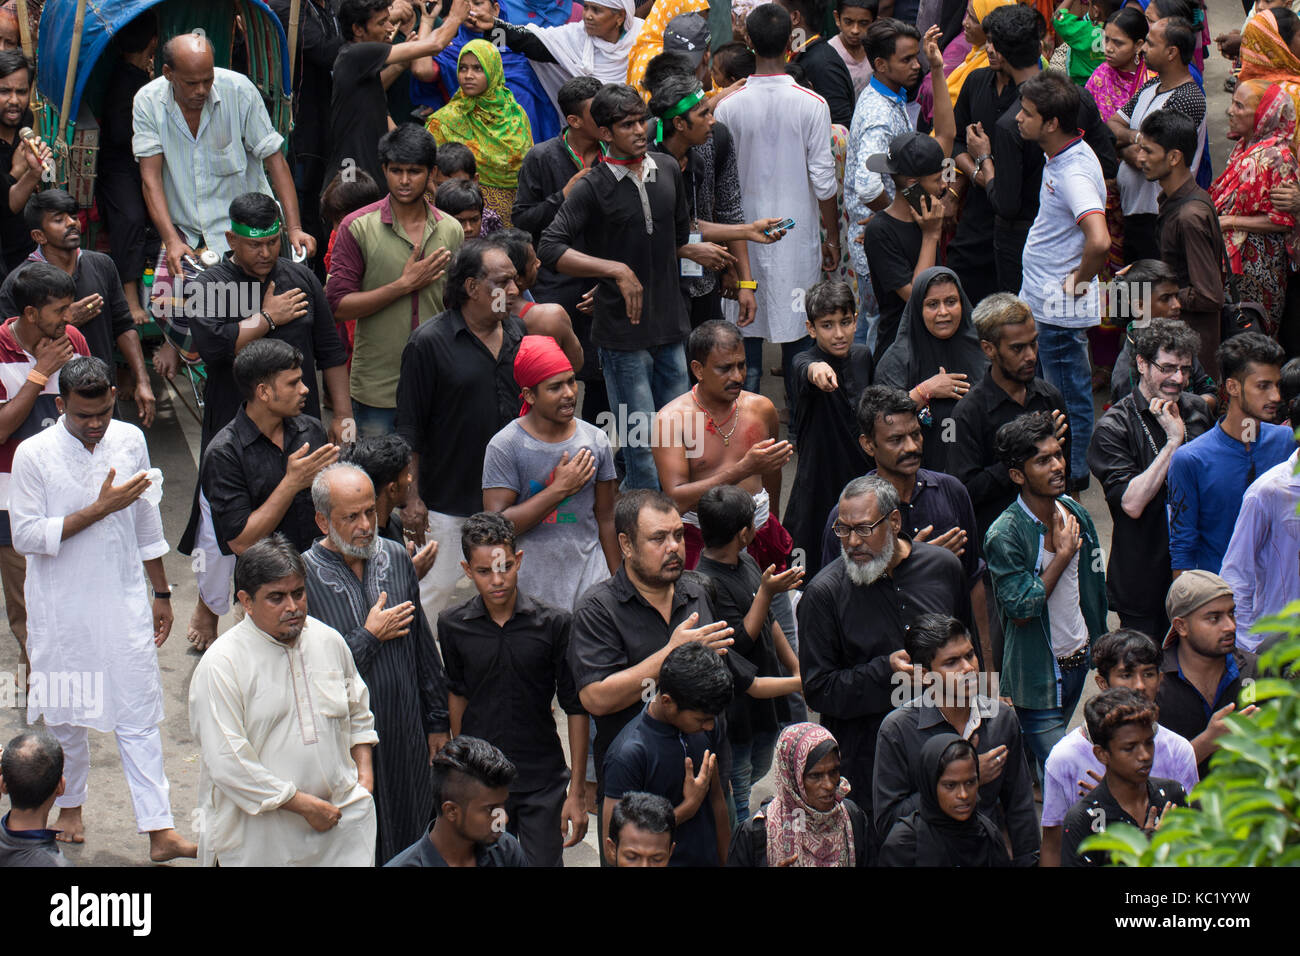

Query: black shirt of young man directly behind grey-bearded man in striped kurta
[199,406,329,554]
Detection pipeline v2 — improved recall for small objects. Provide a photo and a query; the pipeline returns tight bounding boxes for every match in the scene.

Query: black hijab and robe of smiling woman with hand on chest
[876,265,988,471]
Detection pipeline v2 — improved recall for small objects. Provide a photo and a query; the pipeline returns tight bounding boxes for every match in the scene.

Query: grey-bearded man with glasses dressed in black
[798,475,971,813]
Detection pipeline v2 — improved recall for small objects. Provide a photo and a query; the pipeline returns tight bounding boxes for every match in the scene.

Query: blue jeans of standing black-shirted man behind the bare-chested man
[601,342,690,492]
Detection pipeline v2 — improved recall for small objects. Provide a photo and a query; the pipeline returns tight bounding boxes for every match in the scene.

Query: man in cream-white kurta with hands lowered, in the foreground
[190,536,378,866]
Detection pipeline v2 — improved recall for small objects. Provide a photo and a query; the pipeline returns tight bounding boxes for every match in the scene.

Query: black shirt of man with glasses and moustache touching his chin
[1088,390,1214,621]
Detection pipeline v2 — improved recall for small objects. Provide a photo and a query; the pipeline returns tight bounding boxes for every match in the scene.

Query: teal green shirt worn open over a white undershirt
[984,496,1106,710]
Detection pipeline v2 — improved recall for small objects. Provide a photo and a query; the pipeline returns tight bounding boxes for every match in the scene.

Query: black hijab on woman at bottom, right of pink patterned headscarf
[917,734,1008,866]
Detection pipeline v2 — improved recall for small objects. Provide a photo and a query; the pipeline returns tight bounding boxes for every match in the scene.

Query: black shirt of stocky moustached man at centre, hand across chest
[569,566,753,796]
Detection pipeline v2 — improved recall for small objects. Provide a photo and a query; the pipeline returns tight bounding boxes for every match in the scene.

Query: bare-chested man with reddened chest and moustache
[654,320,794,571]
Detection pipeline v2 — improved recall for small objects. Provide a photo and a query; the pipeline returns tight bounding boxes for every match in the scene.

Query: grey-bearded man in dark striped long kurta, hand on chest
[303,463,450,866]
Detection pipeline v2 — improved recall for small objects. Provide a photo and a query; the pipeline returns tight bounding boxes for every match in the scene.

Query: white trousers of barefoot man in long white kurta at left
[49,723,174,834]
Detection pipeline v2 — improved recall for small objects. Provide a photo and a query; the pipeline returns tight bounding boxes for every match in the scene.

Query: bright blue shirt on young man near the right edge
[1169,424,1296,574]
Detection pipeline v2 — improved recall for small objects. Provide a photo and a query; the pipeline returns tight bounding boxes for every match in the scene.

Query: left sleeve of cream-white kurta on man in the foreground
[190,657,298,816]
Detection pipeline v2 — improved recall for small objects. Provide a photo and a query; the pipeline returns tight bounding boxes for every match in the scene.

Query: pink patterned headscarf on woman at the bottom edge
[764,723,857,866]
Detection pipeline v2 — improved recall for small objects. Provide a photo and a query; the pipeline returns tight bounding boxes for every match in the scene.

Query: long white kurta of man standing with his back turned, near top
[715,44,840,361]
